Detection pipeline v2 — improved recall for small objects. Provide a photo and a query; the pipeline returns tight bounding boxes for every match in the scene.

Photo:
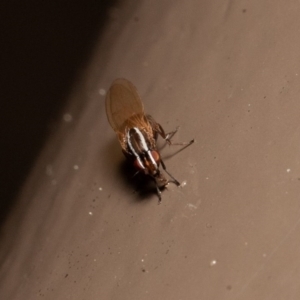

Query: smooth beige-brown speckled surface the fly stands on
[0,0,300,300]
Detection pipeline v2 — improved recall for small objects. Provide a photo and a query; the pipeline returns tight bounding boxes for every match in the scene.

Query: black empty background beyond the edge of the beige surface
[0,0,116,226]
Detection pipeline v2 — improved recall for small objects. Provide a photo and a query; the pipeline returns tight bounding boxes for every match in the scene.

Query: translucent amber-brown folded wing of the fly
[105,78,144,131]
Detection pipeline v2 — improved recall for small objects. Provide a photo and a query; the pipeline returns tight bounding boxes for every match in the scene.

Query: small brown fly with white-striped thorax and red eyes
[105,78,194,203]
